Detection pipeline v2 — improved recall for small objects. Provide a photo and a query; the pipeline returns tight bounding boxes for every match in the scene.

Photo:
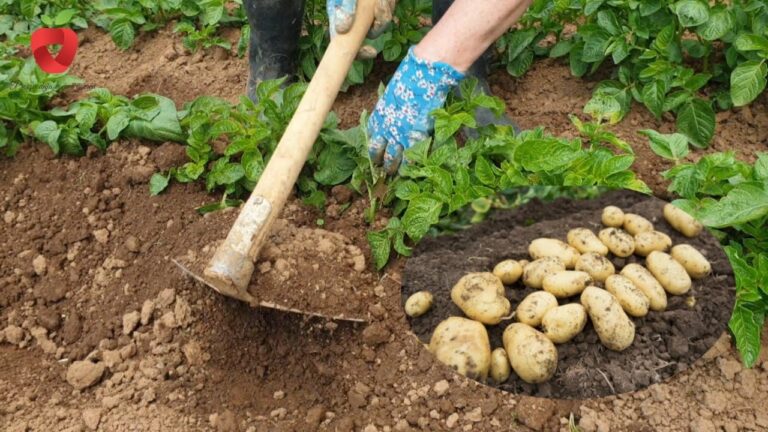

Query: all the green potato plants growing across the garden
[0,0,768,365]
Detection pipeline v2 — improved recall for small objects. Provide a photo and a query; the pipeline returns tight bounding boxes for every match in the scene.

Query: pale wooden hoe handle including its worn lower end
[204,0,375,303]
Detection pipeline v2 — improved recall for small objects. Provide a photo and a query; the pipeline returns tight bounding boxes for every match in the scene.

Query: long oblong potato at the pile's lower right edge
[581,286,635,351]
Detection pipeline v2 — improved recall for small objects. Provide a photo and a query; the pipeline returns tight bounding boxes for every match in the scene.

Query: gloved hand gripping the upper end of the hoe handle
[326,0,397,59]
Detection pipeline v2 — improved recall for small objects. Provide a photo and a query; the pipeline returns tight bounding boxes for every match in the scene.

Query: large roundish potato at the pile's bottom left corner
[429,317,491,381]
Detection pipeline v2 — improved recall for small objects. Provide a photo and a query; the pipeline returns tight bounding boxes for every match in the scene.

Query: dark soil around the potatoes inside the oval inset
[403,191,735,399]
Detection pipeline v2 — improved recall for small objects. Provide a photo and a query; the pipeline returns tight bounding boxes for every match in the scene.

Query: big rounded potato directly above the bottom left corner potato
[451,272,511,325]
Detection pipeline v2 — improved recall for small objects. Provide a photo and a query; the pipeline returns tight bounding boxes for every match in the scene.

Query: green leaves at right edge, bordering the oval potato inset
[664,152,768,367]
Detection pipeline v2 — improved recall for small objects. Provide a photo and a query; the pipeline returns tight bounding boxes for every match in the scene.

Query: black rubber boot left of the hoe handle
[243,0,304,102]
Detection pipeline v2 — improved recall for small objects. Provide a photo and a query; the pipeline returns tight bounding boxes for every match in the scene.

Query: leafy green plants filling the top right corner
[497,0,768,148]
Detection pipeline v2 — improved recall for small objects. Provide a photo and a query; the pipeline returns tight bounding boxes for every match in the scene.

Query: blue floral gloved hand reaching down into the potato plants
[368,48,464,174]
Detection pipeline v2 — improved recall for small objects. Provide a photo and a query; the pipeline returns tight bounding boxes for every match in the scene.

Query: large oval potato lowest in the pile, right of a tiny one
[502,323,557,384]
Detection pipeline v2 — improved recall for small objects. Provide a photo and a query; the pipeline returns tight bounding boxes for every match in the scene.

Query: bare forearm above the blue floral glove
[414,0,533,72]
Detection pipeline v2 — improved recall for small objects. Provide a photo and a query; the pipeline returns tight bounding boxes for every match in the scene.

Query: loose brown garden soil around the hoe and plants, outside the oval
[0,26,768,432]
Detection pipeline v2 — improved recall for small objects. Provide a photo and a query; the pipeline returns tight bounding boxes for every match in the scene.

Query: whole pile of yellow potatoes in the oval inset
[405,204,711,384]
